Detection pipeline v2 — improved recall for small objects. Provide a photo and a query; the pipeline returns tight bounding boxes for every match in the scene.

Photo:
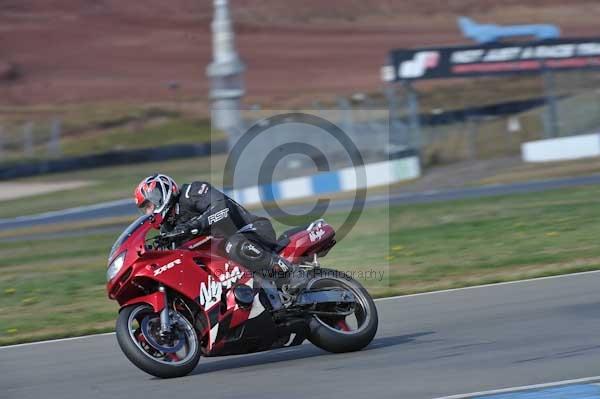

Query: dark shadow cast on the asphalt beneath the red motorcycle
[190,331,434,375]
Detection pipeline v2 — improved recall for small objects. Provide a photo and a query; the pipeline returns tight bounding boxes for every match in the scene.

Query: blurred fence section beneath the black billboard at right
[388,71,600,165]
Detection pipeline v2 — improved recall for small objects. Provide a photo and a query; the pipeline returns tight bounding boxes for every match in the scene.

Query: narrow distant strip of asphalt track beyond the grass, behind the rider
[0,175,600,231]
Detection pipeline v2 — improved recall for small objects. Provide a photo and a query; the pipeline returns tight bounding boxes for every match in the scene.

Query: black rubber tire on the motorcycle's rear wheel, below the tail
[306,269,379,353]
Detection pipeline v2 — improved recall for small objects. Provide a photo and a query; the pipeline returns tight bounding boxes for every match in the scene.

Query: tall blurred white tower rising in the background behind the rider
[206,0,245,147]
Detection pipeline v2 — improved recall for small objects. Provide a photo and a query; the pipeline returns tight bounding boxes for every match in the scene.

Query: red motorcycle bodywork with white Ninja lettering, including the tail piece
[108,220,335,356]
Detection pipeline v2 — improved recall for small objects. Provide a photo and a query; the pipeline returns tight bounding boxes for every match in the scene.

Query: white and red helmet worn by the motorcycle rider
[134,174,179,216]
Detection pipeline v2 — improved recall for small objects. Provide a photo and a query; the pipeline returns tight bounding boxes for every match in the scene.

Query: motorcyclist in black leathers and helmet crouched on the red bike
[134,174,305,294]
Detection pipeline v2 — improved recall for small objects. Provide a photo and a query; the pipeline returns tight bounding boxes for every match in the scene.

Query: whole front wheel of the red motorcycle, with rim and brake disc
[116,304,201,378]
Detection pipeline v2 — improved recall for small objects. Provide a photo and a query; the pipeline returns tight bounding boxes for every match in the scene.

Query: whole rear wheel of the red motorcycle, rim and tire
[306,269,379,353]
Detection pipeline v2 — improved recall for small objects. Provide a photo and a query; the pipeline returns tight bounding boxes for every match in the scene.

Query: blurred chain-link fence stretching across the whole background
[0,71,600,172]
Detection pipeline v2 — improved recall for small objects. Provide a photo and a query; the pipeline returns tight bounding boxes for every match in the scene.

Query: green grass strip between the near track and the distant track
[0,187,600,344]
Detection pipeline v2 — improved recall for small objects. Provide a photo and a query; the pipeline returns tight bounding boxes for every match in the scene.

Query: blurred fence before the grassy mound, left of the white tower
[0,105,213,164]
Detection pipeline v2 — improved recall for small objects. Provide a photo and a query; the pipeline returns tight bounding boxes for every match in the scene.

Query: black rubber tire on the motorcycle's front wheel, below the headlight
[116,304,201,378]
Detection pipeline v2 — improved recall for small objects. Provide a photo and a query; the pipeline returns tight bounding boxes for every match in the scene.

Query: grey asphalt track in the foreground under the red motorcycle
[0,272,600,399]
